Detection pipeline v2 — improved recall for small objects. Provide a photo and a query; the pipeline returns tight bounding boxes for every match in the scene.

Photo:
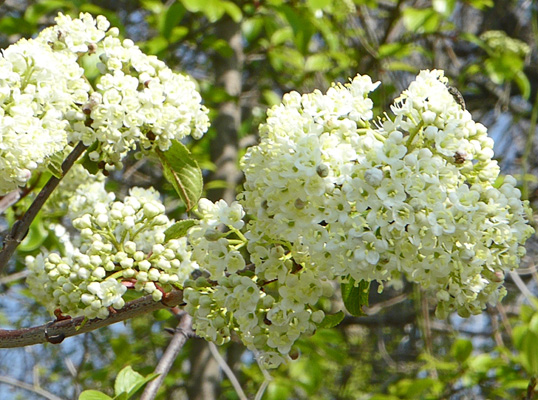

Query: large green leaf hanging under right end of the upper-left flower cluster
[156,140,203,211]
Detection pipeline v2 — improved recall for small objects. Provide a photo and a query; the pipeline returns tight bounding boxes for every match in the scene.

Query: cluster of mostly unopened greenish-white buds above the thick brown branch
[26,182,198,318]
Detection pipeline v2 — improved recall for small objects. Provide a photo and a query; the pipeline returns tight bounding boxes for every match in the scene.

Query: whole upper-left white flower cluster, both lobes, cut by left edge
[0,14,209,195]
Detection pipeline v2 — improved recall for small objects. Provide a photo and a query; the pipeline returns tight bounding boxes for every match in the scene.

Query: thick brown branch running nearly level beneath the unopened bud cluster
[0,289,183,348]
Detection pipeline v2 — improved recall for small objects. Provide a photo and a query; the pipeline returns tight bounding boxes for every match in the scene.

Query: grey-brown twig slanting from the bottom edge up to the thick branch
[140,312,194,400]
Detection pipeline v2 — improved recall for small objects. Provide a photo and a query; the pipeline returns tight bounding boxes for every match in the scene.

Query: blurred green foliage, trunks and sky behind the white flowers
[0,0,538,400]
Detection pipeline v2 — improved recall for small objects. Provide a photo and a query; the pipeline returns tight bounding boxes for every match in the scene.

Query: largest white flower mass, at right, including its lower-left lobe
[181,71,533,366]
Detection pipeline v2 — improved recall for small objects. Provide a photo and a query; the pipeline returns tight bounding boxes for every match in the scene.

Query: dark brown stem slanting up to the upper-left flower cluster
[0,142,87,272]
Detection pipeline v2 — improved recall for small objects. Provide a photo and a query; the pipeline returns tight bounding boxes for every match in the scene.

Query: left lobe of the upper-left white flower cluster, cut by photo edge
[0,39,90,195]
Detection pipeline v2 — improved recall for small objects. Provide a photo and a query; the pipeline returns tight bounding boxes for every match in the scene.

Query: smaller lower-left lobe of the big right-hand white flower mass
[184,199,332,367]
